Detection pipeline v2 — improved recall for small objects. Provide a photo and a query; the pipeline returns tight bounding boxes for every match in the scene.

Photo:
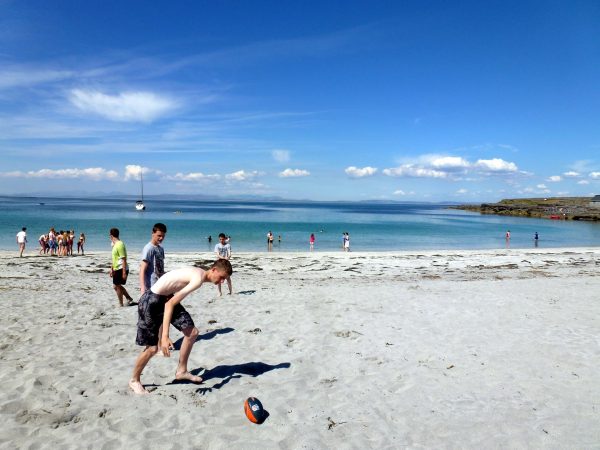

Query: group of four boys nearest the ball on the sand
[109,223,233,394]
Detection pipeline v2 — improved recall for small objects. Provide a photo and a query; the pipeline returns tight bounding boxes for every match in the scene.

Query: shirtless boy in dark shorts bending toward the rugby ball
[129,259,233,394]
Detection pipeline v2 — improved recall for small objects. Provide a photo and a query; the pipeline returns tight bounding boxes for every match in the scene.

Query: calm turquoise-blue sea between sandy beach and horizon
[0,197,600,254]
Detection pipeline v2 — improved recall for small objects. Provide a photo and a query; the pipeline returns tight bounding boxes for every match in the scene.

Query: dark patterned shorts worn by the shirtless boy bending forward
[135,289,194,345]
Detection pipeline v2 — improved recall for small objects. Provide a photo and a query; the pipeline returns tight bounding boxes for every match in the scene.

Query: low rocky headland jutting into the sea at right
[450,197,600,221]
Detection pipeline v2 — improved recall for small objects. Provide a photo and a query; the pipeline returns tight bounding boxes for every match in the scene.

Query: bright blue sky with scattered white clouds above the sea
[0,0,600,202]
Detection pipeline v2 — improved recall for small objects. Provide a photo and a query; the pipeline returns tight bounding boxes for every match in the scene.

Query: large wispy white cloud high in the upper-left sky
[70,89,177,122]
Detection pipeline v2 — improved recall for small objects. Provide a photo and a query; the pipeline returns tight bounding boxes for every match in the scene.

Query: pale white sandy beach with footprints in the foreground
[0,248,600,449]
